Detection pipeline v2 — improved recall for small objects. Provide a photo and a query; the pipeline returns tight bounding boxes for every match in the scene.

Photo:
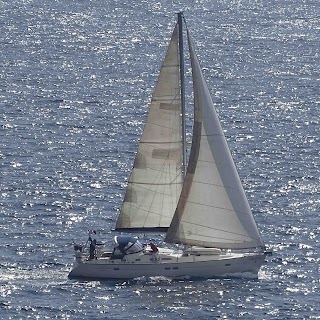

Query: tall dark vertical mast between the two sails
[178,12,187,178]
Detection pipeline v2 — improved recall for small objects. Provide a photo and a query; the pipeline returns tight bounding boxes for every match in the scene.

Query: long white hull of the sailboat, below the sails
[69,250,265,279]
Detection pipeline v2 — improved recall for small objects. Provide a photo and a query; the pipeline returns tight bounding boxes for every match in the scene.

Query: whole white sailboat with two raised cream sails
[69,13,267,279]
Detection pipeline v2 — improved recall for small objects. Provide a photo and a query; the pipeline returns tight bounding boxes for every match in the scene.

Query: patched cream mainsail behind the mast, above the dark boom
[116,26,182,232]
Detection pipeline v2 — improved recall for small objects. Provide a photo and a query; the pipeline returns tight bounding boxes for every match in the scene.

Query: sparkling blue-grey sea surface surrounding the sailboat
[0,0,320,320]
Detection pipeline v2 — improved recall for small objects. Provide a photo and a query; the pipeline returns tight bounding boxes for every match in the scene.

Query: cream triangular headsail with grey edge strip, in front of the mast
[166,30,263,249]
